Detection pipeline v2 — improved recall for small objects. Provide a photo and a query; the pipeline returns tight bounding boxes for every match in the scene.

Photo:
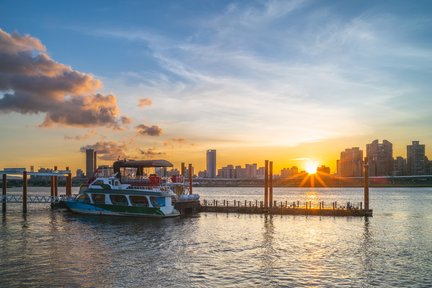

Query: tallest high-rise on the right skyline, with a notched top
[366,140,394,176]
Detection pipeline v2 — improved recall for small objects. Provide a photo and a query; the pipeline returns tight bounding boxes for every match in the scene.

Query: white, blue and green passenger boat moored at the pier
[65,160,199,218]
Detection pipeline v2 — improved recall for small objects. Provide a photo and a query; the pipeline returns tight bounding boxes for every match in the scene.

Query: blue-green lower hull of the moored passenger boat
[65,200,180,218]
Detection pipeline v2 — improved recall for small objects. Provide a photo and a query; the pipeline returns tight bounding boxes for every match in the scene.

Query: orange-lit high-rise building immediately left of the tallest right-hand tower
[337,147,363,177]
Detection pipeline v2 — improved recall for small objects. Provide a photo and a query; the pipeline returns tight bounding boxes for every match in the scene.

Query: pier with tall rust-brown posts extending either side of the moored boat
[0,157,373,217]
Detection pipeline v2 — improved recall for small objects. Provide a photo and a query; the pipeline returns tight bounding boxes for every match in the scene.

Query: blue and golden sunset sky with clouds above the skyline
[0,0,432,171]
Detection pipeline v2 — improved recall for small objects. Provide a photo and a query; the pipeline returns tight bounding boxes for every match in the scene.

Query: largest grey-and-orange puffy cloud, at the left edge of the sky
[0,29,128,128]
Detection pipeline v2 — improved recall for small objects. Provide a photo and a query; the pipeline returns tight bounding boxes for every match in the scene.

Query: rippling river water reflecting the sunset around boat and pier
[0,188,432,287]
